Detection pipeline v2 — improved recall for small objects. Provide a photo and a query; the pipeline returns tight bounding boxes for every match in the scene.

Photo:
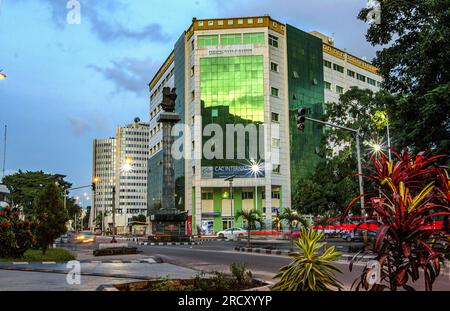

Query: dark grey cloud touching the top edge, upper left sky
[16,0,171,42]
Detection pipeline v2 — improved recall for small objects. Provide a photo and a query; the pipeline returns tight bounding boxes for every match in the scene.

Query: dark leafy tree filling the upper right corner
[358,0,450,154]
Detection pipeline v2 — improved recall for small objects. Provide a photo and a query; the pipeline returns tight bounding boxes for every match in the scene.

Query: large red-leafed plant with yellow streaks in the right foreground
[342,149,450,290]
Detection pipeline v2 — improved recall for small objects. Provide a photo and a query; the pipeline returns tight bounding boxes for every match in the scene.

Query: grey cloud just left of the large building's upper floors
[88,58,159,96]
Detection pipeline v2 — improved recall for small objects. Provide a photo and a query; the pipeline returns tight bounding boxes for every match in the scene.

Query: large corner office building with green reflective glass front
[148,16,381,232]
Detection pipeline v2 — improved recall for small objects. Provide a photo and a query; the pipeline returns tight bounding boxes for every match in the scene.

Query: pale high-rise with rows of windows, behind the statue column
[91,118,149,233]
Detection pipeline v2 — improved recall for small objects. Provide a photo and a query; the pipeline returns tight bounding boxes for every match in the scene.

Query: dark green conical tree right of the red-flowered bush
[33,183,69,254]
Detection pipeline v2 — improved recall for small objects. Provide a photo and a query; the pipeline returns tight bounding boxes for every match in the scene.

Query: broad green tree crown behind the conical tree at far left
[3,170,72,215]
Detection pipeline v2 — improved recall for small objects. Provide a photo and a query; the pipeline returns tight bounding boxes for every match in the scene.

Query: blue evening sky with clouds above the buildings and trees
[0,0,375,199]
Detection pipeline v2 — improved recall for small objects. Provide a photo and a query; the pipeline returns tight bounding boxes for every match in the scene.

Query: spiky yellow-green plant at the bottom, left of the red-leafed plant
[272,228,342,291]
